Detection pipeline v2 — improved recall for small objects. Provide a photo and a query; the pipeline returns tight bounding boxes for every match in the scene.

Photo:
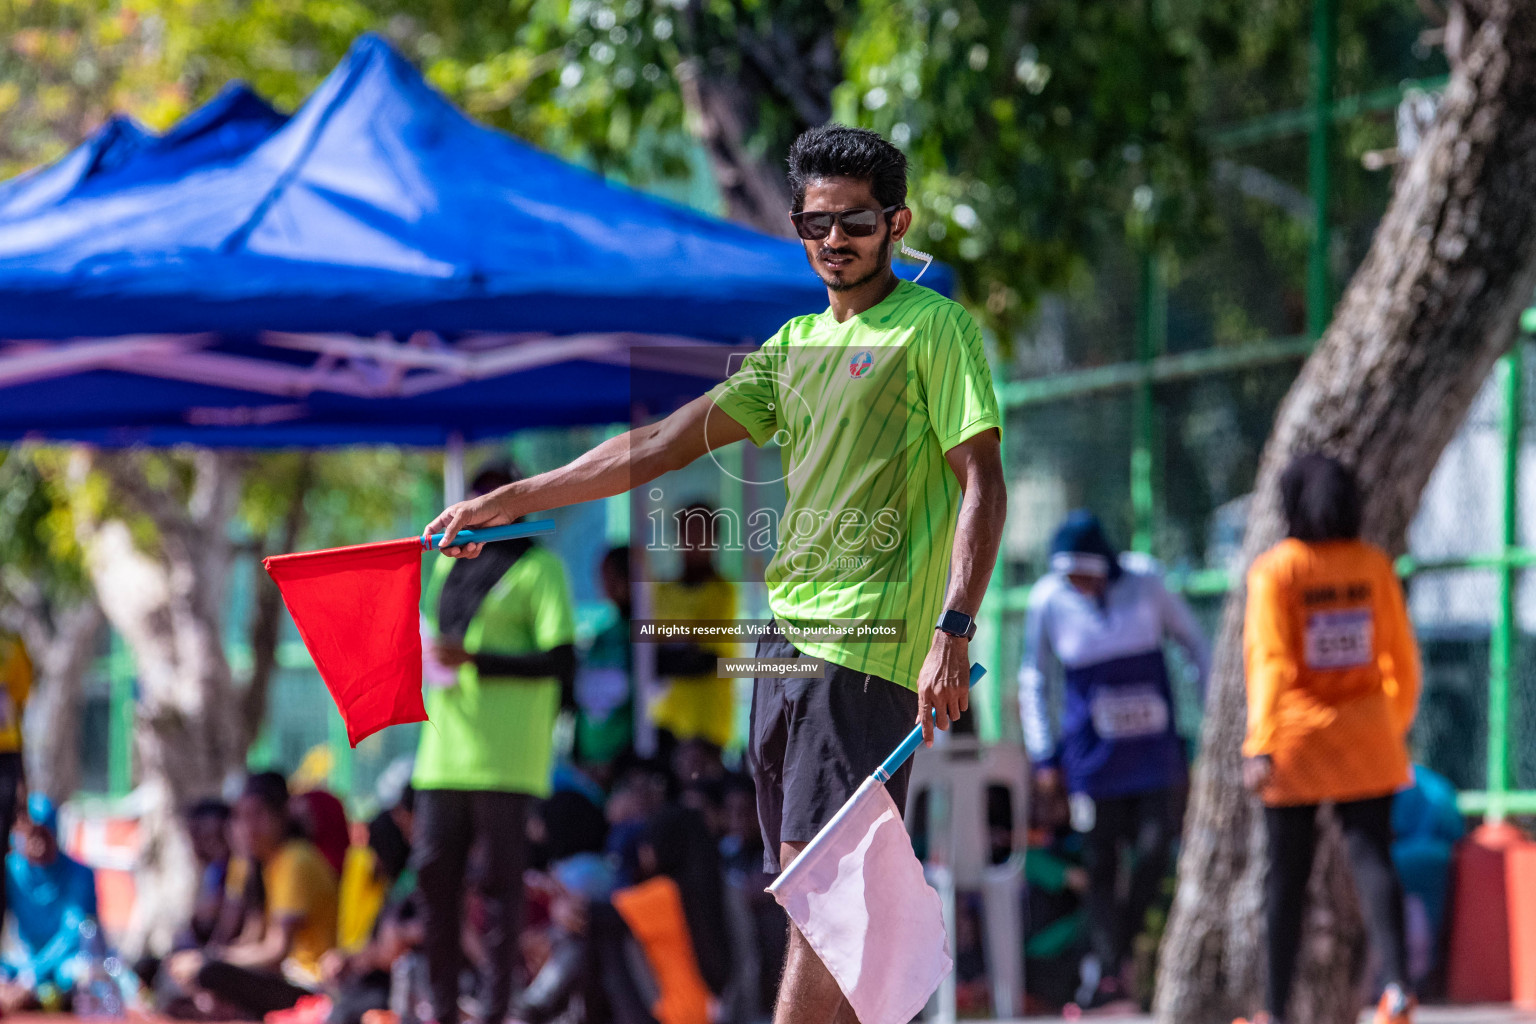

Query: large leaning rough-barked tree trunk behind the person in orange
[1155,0,1536,1024]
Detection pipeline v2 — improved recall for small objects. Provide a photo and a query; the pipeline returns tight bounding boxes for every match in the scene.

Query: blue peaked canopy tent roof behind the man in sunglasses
[0,35,946,445]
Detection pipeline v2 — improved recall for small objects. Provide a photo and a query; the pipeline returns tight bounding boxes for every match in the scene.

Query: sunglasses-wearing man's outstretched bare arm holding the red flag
[425,395,748,559]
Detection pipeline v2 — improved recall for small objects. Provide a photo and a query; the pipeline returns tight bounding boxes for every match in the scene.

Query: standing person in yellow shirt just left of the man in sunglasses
[651,504,736,760]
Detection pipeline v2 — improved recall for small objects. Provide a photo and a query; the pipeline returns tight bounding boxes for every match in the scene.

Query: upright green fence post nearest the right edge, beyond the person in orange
[1487,348,1524,821]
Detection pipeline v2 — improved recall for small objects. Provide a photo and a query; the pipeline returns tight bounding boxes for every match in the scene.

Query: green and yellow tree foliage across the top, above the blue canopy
[0,0,1444,353]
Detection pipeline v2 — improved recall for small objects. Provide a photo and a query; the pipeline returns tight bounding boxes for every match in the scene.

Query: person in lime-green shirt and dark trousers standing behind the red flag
[412,468,576,1024]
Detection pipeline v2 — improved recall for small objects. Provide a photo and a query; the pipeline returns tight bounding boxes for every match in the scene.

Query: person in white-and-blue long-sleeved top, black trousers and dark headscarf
[1018,510,1209,1007]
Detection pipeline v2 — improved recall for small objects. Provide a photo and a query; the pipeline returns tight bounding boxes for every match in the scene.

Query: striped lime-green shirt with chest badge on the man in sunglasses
[710,281,1001,689]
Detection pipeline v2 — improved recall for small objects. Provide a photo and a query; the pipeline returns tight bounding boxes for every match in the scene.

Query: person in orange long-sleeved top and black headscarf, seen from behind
[1243,454,1419,1024]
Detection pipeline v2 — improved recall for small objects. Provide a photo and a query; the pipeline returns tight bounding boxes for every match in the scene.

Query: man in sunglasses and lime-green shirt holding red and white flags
[427,124,1006,1024]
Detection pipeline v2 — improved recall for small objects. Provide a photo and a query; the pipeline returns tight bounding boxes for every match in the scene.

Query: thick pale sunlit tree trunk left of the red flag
[72,451,244,953]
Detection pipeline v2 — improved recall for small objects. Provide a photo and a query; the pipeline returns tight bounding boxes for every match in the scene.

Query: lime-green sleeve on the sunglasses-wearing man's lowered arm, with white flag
[917,302,1003,451]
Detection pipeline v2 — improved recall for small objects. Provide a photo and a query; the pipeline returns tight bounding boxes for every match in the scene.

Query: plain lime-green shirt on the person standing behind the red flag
[412,545,576,797]
